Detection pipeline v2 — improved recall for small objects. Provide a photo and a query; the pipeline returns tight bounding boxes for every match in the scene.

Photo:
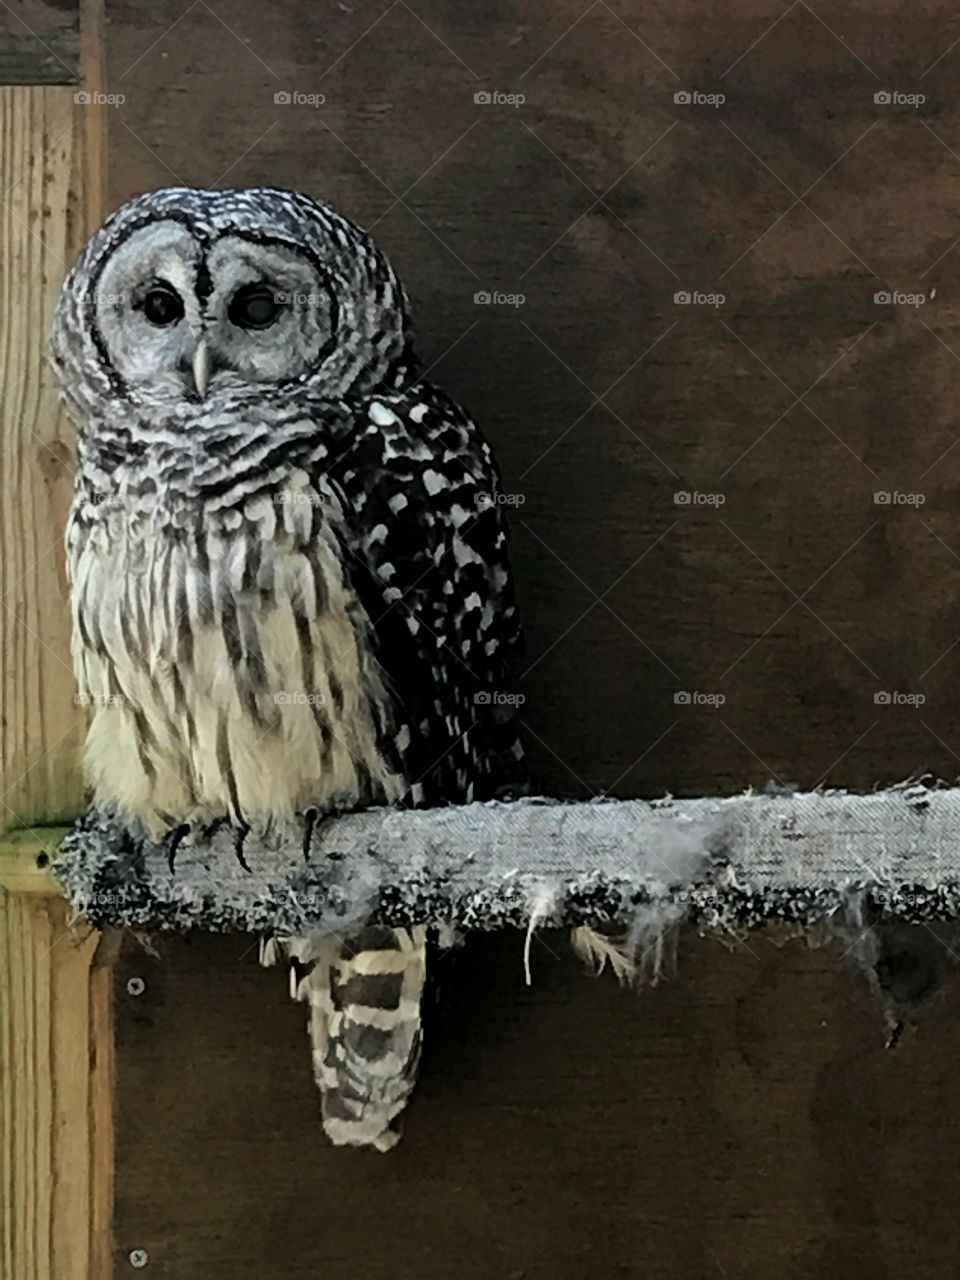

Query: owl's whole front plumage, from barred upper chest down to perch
[68,439,404,838]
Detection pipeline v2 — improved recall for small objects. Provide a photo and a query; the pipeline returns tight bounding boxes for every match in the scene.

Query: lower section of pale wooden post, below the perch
[0,891,113,1280]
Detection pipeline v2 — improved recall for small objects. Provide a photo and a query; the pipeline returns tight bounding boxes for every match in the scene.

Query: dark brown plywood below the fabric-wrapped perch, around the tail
[116,932,960,1280]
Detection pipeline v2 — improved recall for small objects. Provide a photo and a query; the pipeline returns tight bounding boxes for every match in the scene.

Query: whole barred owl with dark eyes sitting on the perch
[50,188,522,1149]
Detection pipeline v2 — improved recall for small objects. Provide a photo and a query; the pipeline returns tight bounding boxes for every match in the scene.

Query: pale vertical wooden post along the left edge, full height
[0,0,113,1280]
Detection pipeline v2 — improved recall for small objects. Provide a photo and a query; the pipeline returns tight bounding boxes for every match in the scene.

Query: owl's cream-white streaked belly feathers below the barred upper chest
[70,486,403,838]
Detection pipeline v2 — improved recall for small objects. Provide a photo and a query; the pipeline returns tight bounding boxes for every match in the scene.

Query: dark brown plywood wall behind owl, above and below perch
[20,0,960,1280]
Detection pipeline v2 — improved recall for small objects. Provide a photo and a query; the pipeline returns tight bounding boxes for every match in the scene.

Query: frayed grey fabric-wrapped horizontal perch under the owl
[56,783,960,933]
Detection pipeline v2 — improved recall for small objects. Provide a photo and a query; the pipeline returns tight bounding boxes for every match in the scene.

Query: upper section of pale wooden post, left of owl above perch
[0,88,84,828]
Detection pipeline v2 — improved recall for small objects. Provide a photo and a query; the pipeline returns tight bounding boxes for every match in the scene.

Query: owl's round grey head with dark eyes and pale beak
[50,187,415,428]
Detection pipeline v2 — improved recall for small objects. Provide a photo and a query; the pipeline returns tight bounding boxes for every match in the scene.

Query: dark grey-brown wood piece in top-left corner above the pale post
[0,0,81,84]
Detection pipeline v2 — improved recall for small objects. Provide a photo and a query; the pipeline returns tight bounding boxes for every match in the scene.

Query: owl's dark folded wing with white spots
[325,383,524,805]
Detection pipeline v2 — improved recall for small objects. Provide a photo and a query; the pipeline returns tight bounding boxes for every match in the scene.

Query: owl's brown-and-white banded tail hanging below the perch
[264,927,426,1151]
